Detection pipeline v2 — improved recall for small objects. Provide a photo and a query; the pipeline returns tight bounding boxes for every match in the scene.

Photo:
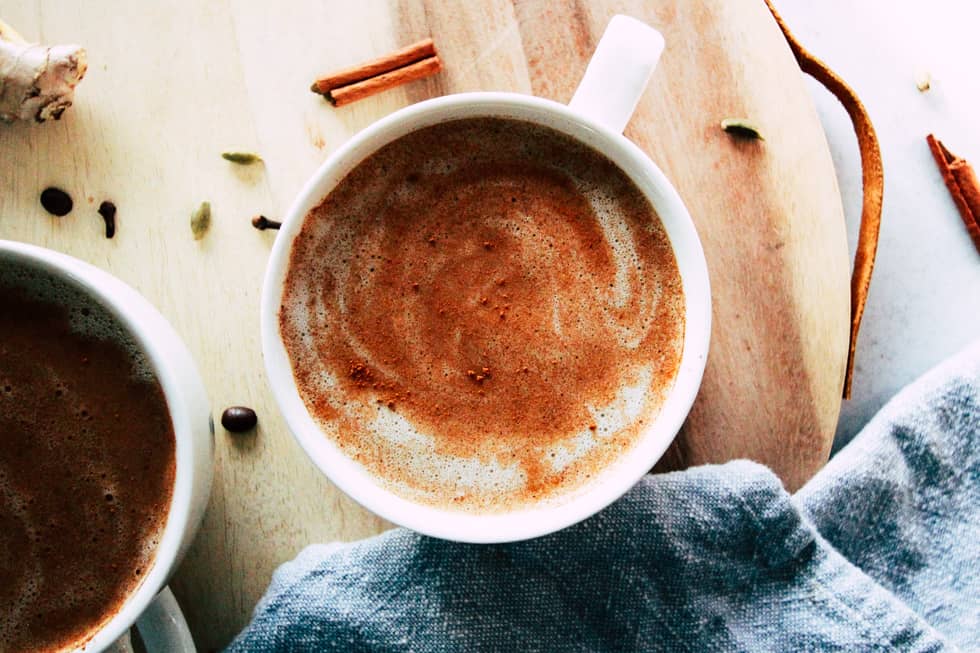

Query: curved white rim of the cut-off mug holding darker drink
[0,240,205,652]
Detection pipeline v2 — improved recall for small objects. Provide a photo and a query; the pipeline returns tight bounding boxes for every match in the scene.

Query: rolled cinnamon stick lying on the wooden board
[310,39,442,107]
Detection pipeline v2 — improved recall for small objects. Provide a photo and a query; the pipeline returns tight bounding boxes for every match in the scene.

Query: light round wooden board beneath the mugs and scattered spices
[0,0,849,650]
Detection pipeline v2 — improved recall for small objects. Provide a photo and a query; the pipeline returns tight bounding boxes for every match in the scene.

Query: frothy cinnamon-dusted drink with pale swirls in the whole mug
[279,118,684,512]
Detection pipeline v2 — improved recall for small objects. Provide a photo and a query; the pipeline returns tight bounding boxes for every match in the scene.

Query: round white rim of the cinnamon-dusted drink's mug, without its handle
[260,92,711,543]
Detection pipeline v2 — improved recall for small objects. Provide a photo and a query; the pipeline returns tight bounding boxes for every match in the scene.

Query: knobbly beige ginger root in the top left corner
[0,20,88,123]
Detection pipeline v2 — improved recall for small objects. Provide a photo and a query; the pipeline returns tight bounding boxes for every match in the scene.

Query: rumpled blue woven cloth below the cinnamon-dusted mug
[229,342,980,652]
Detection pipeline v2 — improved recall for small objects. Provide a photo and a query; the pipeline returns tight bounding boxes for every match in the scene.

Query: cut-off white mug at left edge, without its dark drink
[0,240,214,653]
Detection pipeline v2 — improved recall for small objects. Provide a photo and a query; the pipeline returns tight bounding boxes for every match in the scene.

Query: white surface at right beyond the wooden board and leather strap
[775,0,980,448]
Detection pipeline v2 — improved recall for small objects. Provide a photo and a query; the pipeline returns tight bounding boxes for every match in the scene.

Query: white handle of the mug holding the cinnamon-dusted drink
[568,15,664,134]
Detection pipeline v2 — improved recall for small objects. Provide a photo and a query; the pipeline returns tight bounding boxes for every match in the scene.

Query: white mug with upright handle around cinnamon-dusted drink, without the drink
[261,16,711,543]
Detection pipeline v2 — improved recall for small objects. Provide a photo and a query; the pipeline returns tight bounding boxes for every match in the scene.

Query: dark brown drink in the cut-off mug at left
[0,261,176,653]
